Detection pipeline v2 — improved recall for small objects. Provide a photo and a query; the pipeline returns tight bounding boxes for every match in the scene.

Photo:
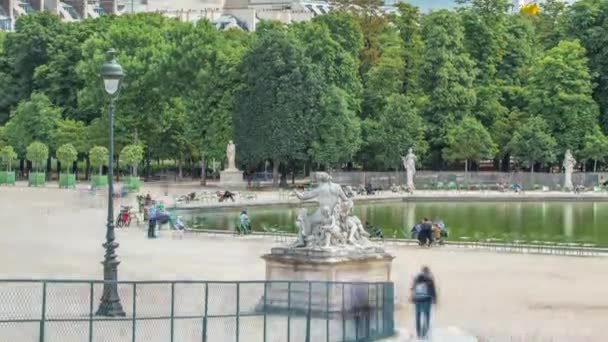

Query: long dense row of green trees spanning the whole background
[0,0,608,186]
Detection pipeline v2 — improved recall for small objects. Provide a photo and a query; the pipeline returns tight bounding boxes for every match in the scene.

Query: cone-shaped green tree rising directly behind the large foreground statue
[309,86,361,167]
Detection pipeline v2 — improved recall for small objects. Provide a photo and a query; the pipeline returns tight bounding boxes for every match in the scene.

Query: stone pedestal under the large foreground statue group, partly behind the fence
[260,246,394,312]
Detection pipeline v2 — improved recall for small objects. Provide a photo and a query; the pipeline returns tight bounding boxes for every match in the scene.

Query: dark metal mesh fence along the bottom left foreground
[0,280,394,342]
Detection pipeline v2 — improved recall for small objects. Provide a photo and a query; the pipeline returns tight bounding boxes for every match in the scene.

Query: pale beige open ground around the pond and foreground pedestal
[0,187,608,342]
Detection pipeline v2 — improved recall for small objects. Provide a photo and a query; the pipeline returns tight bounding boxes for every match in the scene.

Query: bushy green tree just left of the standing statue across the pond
[365,94,428,169]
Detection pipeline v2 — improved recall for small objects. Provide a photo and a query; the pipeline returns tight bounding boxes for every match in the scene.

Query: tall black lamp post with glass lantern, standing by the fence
[97,49,125,317]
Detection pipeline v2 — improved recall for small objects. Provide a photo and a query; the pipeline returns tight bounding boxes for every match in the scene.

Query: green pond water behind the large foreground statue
[180,201,608,247]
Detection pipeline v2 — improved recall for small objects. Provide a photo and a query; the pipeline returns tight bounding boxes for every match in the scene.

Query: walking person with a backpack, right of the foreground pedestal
[411,266,437,339]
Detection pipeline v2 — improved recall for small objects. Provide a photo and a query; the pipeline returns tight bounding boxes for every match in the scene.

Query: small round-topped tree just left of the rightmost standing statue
[507,116,557,172]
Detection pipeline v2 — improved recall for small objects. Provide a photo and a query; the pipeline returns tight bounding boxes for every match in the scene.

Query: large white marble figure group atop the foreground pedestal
[292,172,370,248]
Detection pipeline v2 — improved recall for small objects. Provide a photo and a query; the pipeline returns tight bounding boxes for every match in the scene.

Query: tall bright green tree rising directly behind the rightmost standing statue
[528,41,598,154]
